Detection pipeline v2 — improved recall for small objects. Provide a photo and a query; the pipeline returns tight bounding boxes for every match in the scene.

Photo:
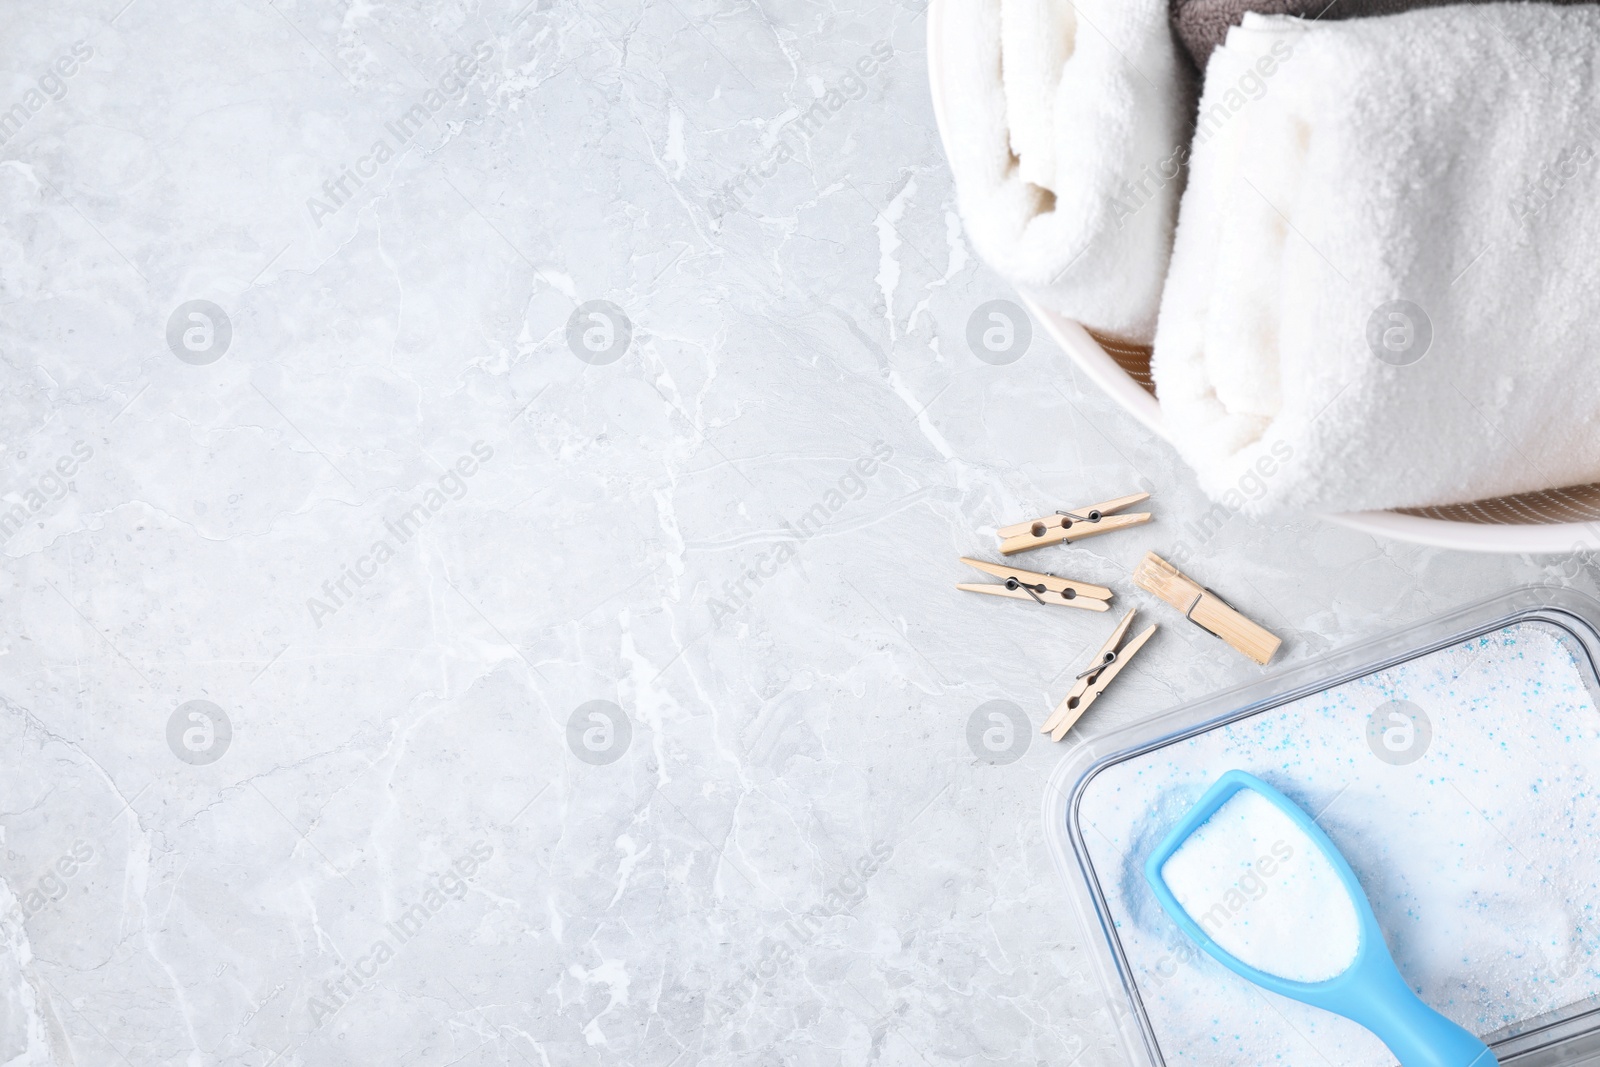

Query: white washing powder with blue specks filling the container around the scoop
[1078,622,1600,1067]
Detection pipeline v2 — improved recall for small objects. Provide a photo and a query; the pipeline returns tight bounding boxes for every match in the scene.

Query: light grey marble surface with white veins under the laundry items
[0,0,1594,1067]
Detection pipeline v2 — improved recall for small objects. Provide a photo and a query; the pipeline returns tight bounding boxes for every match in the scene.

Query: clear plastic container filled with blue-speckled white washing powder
[1045,587,1600,1067]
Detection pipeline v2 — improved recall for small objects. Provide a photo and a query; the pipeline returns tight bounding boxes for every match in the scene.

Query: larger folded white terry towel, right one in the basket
[1152,3,1600,515]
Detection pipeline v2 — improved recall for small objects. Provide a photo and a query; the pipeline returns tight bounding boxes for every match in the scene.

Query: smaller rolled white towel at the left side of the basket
[933,0,1194,344]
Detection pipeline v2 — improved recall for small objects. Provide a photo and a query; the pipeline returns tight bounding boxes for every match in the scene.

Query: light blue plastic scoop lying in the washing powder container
[1144,771,1499,1067]
